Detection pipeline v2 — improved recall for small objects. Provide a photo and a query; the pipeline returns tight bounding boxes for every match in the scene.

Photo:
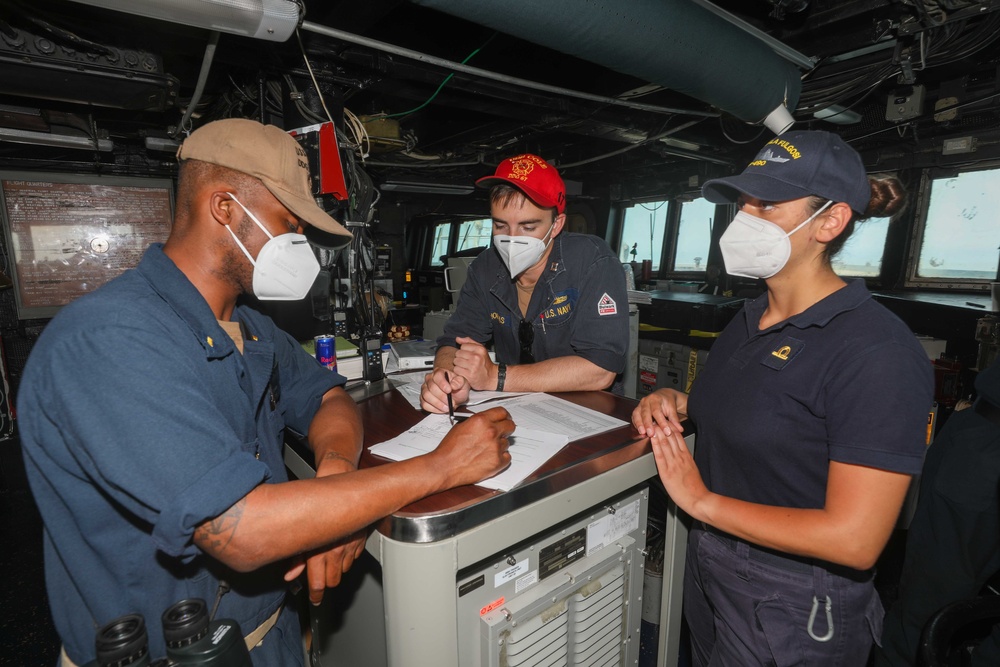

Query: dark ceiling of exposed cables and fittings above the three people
[0,0,1000,197]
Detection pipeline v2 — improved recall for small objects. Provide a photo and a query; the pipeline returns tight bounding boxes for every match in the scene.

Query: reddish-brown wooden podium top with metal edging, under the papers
[293,382,651,543]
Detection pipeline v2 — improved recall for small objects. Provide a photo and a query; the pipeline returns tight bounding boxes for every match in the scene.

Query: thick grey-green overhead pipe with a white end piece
[412,0,802,134]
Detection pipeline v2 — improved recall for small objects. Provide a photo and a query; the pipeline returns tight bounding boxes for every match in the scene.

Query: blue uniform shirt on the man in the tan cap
[18,245,343,666]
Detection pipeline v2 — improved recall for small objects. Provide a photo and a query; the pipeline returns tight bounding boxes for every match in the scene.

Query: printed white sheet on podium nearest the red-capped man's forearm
[469,393,628,442]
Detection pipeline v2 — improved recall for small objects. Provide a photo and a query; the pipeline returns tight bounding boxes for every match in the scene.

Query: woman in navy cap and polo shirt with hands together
[632,132,933,667]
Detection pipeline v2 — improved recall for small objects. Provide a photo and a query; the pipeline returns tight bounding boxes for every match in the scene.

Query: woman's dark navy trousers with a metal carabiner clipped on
[684,528,883,667]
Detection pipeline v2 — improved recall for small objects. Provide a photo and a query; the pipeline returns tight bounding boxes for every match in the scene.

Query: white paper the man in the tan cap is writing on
[370,415,569,491]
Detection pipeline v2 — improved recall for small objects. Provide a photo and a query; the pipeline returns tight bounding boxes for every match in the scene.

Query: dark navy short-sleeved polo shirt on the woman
[688,280,934,508]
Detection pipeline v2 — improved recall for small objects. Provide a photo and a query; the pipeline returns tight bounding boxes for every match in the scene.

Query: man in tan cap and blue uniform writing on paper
[18,119,513,667]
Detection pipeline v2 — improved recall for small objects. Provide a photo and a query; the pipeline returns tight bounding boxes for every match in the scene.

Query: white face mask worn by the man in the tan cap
[226,194,319,301]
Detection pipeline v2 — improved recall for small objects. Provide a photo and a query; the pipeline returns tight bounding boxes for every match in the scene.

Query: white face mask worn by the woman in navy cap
[719,200,833,278]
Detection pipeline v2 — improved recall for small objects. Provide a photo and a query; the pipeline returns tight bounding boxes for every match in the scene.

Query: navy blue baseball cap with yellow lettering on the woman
[701,130,871,215]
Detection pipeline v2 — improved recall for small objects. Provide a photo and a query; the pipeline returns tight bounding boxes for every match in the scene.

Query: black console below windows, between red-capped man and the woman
[639,291,744,336]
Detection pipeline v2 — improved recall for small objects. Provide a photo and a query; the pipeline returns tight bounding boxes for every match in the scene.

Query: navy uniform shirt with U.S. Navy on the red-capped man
[437,232,628,373]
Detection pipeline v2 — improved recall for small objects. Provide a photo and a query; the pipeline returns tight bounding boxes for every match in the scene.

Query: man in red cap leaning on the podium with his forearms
[420,154,628,412]
